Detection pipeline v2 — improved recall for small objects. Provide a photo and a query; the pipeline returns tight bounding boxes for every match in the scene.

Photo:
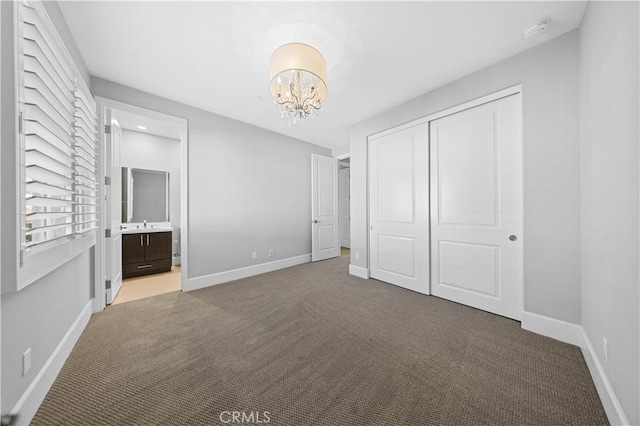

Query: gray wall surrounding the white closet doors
[350,31,581,324]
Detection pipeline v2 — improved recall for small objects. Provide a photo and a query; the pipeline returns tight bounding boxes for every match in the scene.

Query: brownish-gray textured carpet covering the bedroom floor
[33,256,607,426]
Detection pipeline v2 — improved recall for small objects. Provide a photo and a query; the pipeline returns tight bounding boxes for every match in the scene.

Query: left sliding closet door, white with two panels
[369,123,429,294]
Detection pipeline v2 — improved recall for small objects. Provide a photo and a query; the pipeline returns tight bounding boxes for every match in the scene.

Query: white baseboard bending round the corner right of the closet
[522,312,629,425]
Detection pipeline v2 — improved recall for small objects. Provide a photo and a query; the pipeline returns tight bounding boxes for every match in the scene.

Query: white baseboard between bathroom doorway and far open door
[182,253,311,291]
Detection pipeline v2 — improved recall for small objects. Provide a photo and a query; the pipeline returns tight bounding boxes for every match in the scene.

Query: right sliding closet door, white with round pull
[430,94,523,319]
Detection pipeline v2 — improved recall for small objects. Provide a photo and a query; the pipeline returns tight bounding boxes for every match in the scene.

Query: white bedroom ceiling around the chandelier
[60,1,586,148]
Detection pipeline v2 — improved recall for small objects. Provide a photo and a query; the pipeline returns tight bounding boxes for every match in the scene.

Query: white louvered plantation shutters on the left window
[20,1,98,257]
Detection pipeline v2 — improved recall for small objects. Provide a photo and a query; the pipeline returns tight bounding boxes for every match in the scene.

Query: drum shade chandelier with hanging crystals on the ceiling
[269,43,327,125]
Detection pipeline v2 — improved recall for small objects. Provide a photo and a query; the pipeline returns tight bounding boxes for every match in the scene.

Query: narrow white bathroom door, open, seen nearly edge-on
[105,115,122,304]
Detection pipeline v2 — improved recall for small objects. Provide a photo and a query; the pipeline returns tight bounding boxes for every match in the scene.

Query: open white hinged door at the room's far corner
[311,154,340,262]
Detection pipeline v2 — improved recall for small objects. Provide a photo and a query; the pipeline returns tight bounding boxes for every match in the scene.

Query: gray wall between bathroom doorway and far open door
[91,78,330,278]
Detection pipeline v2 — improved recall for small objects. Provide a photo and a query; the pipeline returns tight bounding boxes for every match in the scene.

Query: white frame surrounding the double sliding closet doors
[366,84,524,312]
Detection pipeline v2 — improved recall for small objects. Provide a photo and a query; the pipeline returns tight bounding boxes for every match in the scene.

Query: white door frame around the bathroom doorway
[93,96,189,313]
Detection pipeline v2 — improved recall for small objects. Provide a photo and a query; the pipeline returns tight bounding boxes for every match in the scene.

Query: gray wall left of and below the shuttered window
[0,1,93,413]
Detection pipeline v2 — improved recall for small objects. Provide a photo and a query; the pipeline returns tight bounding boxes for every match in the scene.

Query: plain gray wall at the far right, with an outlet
[580,2,640,425]
